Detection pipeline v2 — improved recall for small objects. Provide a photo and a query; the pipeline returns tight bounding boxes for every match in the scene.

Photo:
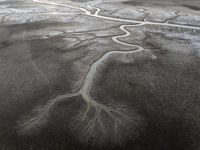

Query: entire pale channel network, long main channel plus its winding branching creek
[19,0,200,134]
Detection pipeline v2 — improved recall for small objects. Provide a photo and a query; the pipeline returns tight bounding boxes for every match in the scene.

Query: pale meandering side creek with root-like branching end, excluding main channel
[19,25,145,134]
